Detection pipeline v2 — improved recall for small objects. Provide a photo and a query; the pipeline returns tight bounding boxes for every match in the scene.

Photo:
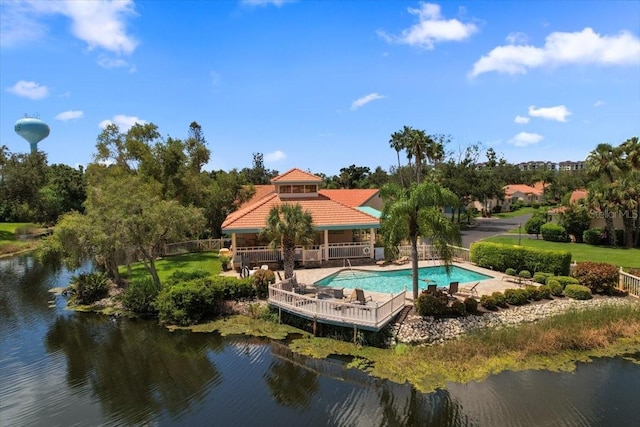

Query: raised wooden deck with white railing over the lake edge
[269,281,406,331]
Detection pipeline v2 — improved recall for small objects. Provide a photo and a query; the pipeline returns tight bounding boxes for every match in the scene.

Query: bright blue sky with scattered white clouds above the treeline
[0,0,640,174]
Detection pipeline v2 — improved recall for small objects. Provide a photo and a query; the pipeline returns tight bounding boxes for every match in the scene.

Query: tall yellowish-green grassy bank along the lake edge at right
[291,304,640,392]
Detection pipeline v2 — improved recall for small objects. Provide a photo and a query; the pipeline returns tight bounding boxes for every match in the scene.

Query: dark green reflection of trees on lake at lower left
[46,315,223,424]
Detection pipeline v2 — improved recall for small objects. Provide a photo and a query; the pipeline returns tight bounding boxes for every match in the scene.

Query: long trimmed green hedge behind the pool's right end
[470,242,571,276]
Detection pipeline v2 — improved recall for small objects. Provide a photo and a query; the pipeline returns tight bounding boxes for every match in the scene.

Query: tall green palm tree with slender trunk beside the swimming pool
[381,182,461,301]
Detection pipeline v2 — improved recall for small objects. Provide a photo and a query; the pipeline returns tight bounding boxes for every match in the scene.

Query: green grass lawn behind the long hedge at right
[483,235,640,268]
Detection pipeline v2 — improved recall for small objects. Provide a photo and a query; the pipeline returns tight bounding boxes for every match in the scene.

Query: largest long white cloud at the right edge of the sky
[469,27,640,77]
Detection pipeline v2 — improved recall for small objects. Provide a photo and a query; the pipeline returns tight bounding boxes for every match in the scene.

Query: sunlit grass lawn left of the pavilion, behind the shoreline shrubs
[120,251,222,282]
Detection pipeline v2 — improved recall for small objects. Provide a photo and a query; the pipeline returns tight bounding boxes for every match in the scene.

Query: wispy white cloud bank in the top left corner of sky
[2,0,138,54]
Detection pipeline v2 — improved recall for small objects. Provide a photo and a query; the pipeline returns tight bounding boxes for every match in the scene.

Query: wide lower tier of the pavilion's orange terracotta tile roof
[222,193,380,232]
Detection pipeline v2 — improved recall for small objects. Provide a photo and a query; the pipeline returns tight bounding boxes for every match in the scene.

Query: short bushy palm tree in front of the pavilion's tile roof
[260,203,315,279]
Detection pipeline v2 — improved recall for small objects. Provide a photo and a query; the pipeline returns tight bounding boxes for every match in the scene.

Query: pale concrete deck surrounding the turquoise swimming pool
[295,261,519,301]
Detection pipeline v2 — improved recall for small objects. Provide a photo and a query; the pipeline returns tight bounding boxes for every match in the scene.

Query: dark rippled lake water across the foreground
[0,256,640,427]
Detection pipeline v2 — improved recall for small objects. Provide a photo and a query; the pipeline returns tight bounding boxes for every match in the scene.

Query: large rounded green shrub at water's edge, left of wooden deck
[156,278,224,326]
